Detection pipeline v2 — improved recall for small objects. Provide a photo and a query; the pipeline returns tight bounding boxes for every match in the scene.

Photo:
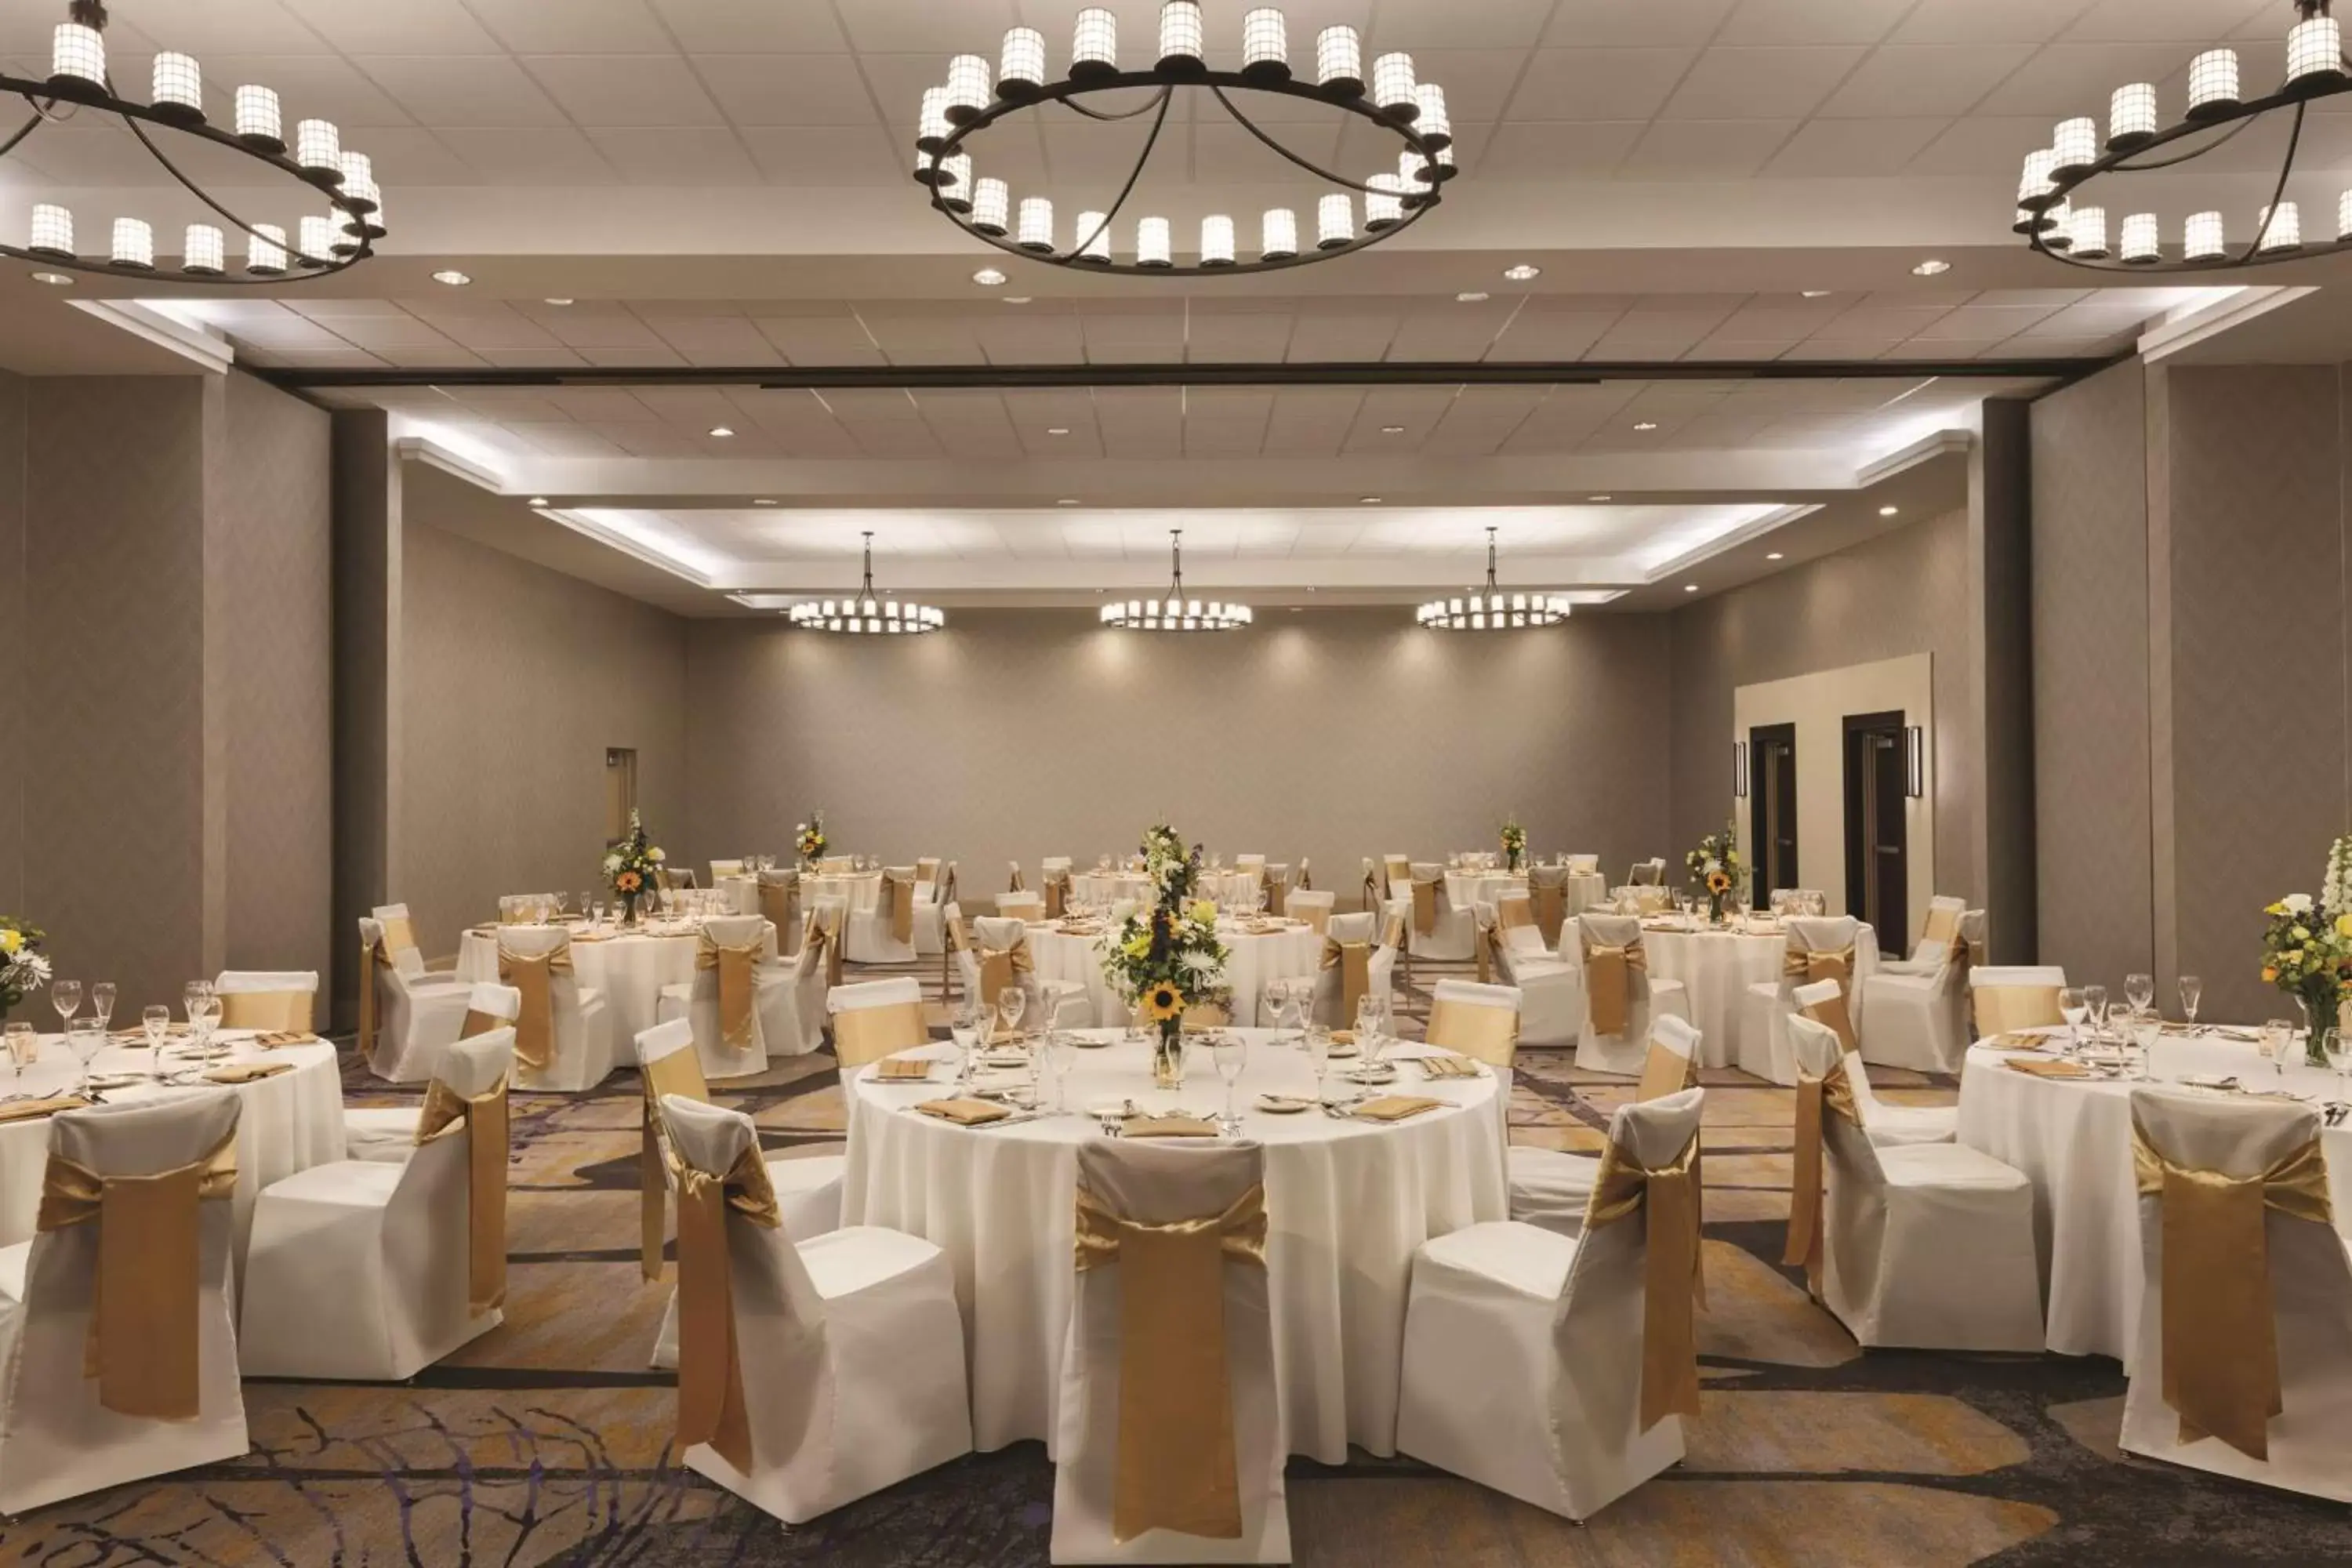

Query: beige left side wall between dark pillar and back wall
[393,515,701,954]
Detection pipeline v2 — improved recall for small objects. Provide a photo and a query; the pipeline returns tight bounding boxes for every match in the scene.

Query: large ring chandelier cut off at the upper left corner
[0,0,383,285]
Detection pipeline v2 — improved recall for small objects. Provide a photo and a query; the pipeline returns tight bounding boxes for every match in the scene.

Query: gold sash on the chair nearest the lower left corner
[35,1128,238,1420]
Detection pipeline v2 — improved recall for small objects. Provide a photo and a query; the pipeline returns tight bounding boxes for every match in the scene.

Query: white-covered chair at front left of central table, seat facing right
[661,1100,971,1523]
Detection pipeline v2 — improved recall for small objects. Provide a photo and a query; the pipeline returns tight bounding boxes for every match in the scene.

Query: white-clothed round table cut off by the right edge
[1959,1029,2352,1373]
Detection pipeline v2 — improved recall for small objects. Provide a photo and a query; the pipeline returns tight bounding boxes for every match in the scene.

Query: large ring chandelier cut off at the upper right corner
[2011,0,2352,273]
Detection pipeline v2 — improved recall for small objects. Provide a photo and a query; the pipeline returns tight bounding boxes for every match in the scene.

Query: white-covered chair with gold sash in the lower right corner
[2122,1088,2352,1502]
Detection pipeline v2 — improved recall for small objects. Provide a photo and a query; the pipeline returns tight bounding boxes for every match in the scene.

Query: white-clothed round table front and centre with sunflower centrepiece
[842,1029,1508,1465]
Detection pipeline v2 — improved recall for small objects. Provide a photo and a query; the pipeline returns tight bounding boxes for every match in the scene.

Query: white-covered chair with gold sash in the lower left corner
[0,1088,252,1516]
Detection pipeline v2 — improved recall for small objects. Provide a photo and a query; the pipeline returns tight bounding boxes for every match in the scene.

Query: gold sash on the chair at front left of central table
[670,1145,783,1469]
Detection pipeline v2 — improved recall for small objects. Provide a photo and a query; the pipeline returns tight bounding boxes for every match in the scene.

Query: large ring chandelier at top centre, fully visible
[915,0,1454,275]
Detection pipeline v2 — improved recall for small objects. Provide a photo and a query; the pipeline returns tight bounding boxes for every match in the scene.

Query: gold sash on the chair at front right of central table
[1585,1133,1708,1432]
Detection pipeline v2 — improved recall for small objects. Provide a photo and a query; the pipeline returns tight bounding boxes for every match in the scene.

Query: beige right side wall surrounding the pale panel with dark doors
[1668,510,1980,907]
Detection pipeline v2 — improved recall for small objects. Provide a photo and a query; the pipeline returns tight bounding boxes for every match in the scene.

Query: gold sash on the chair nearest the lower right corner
[2131,1116,2336,1460]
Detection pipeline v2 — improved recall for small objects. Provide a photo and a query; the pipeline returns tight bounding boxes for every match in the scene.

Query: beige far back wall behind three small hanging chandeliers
[687,609,1668,900]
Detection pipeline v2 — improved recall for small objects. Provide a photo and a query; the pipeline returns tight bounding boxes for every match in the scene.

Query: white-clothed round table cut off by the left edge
[0,1029,343,1258]
